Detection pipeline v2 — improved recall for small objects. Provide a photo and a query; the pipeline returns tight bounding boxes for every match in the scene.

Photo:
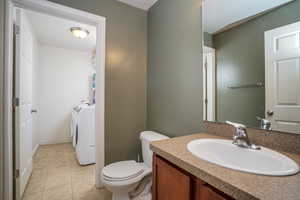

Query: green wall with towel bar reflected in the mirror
[213,0,300,126]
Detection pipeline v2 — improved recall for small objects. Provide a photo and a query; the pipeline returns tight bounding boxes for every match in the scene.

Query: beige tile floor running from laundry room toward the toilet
[24,145,111,200]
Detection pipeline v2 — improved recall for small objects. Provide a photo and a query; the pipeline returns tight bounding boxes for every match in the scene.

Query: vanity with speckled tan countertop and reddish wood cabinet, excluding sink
[151,133,300,200]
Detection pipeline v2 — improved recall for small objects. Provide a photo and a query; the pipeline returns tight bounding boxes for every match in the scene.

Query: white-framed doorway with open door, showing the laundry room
[5,0,109,200]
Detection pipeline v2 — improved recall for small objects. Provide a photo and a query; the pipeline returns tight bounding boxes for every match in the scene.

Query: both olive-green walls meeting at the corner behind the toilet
[0,0,202,166]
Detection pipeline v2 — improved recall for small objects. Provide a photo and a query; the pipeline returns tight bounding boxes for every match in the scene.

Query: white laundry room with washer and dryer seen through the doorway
[16,9,96,197]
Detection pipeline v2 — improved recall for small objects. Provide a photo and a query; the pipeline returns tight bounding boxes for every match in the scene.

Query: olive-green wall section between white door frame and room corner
[51,0,147,163]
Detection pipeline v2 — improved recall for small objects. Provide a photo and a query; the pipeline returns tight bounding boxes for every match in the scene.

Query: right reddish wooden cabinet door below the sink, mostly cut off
[193,179,233,200]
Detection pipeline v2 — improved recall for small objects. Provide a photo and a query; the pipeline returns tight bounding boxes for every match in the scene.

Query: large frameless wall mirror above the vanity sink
[203,0,300,134]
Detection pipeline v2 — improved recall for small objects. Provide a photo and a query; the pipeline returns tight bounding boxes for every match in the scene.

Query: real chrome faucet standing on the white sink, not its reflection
[226,121,261,150]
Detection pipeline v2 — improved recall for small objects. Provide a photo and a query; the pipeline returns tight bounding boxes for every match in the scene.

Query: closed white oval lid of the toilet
[102,160,144,180]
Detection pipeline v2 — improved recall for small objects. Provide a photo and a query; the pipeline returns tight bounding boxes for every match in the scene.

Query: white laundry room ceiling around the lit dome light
[26,11,96,51]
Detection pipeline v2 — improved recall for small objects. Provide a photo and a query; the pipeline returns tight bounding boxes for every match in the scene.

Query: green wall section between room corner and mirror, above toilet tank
[147,0,203,136]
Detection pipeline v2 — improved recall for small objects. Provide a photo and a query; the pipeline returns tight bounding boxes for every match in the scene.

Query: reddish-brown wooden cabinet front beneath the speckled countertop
[153,154,233,200]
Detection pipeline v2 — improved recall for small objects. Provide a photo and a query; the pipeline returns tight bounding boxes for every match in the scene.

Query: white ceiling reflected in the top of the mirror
[203,0,293,33]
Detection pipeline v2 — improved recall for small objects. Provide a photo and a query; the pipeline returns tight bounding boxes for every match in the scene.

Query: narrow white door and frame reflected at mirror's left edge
[203,46,216,121]
